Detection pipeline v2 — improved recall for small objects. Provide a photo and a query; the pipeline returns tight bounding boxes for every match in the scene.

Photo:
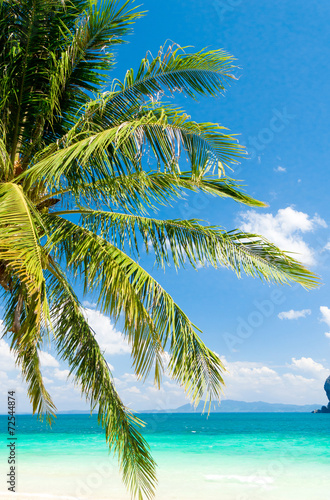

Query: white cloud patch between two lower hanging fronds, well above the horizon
[85,308,131,356]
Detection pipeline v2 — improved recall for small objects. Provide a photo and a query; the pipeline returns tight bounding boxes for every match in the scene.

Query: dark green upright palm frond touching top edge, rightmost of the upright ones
[47,0,143,135]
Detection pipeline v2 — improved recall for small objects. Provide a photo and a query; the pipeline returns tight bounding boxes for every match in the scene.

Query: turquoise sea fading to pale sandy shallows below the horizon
[0,413,330,500]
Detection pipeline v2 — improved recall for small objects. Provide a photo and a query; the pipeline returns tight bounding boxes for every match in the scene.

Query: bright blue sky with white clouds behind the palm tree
[0,0,330,411]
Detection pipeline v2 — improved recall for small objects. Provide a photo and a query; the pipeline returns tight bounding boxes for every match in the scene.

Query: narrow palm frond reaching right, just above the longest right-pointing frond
[38,170,267,214]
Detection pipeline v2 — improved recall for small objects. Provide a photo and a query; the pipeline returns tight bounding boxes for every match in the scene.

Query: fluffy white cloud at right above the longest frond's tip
[240,207,327,265]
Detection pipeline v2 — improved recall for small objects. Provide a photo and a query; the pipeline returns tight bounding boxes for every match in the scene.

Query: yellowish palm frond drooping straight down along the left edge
[0,183,55,421]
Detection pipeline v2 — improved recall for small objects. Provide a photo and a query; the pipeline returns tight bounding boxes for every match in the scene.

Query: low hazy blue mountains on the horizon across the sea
[141,399,321,413]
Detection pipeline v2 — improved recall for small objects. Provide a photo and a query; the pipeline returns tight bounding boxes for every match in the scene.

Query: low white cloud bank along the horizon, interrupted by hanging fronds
[0,350,330,411]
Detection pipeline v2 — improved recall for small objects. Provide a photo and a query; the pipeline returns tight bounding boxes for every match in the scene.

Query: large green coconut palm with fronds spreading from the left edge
[0,0,318,498]
